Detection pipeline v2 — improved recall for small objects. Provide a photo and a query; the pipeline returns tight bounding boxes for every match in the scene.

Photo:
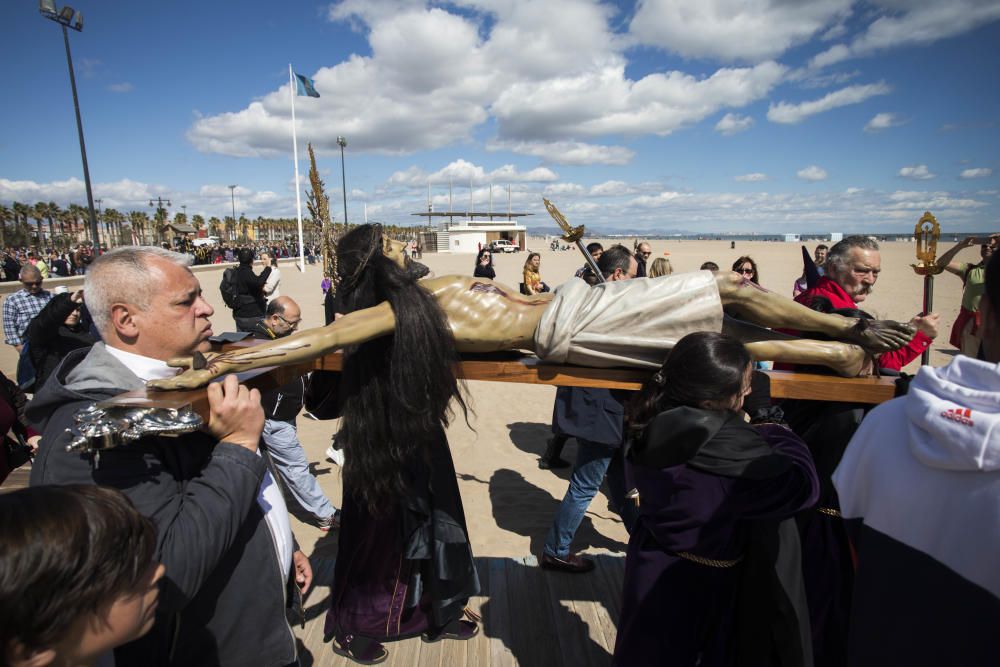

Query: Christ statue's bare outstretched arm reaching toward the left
[147,303,396,390]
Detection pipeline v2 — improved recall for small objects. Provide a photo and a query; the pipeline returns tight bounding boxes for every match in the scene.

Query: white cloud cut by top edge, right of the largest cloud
[629,0,851,62]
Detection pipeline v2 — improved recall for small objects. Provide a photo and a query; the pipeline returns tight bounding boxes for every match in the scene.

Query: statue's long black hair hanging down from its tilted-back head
[337,225,468,515]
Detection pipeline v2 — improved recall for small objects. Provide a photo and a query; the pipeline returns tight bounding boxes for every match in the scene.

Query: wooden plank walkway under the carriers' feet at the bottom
[293,555,625,667]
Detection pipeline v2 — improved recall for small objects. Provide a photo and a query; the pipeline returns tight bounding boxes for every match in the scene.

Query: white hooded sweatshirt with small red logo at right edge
[833,356,1000,596]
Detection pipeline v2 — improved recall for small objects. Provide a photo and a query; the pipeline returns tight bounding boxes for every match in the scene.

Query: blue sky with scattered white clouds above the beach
[0,0,1000,233]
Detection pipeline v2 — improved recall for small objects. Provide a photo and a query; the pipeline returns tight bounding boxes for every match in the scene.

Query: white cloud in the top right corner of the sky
[810,0,1000,68]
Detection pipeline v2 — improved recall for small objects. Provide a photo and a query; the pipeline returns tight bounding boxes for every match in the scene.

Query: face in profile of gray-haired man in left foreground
[133,257,215,361]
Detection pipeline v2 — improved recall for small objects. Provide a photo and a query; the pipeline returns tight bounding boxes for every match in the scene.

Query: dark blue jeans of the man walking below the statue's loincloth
[544,438,638,558]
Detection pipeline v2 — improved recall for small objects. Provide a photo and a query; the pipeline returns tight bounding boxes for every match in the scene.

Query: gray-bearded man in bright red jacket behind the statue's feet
[795,236,940,371]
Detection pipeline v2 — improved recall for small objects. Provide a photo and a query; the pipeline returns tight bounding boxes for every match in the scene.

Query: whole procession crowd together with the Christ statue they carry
[0,231,1000,667]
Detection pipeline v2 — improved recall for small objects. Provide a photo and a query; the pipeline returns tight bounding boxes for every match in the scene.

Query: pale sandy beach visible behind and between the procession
[0,238,978,557]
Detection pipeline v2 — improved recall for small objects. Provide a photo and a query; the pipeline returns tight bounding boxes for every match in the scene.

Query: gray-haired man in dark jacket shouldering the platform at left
[28,247,312,667]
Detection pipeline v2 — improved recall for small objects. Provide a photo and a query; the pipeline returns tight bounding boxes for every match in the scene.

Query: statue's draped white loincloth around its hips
[535,271,722,368]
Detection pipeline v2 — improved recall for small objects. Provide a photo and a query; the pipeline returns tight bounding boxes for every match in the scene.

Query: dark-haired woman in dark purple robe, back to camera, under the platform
[614,332,819,667]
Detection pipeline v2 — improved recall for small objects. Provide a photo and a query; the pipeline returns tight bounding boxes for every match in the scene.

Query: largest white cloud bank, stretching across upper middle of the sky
[187,0,788,159]
